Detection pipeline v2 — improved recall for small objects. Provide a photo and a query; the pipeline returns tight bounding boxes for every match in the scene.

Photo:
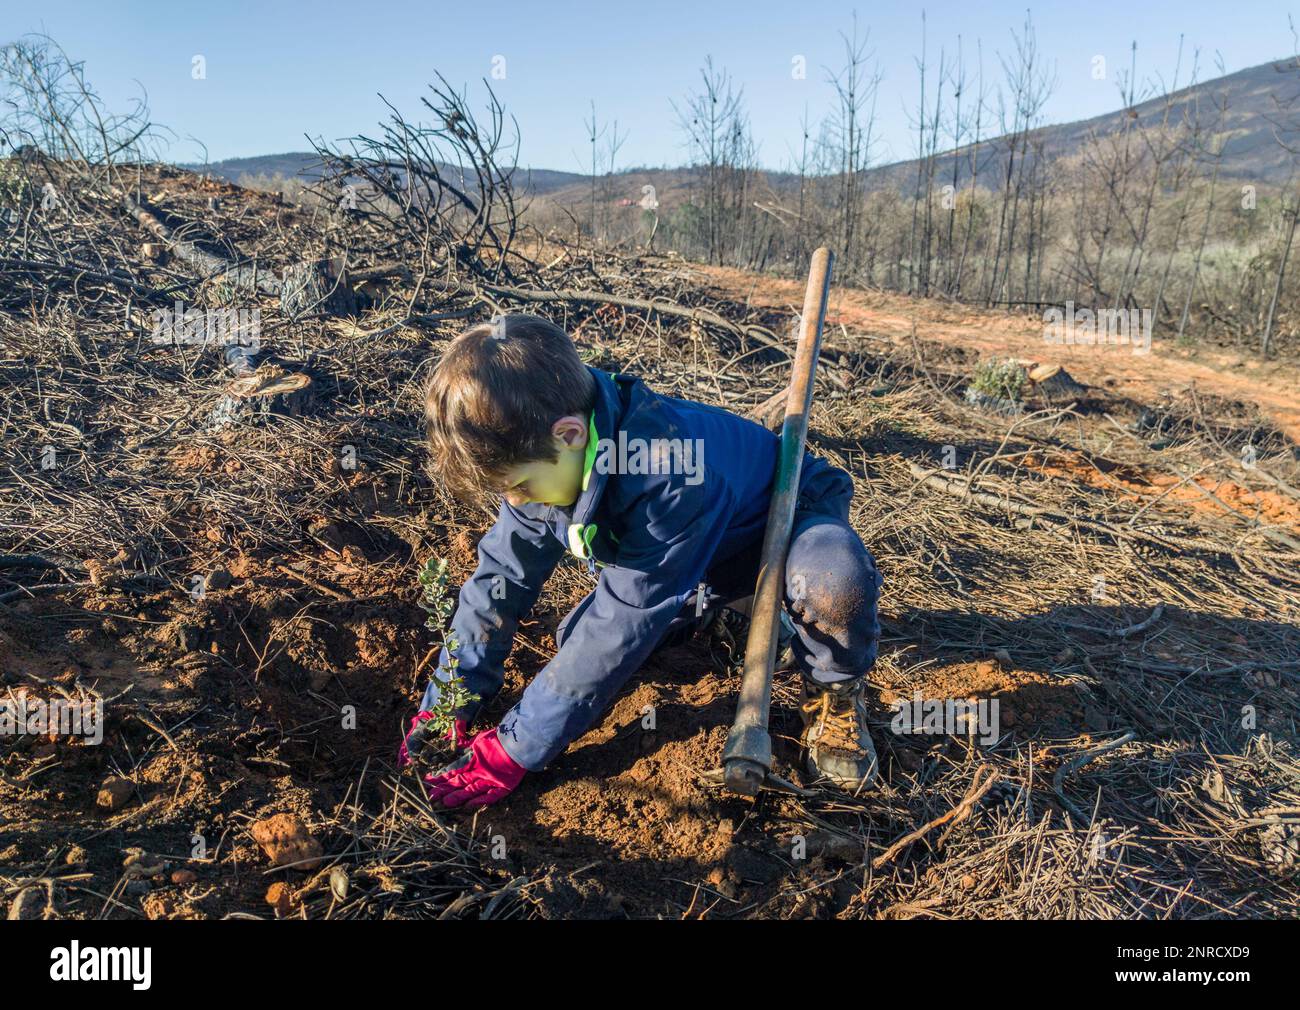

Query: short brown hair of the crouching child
[424,315,595,498]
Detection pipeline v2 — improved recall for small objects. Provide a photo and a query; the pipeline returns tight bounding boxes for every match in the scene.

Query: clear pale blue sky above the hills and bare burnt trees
[10,0,1300,172]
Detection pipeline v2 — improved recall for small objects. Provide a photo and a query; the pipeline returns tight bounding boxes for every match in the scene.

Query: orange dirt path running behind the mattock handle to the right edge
[688,264,1300,442]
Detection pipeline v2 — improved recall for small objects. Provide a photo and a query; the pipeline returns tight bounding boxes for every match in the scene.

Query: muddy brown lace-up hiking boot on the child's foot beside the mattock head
[800,677,879,793]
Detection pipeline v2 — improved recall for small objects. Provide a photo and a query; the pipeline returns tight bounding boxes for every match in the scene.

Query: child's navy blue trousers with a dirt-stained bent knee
[555,469,883,684]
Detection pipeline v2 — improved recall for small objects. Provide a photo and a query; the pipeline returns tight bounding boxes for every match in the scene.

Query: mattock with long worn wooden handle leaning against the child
[712,246,835,796]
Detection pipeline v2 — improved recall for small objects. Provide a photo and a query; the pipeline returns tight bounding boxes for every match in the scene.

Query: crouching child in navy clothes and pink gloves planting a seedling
[399,315,881,807]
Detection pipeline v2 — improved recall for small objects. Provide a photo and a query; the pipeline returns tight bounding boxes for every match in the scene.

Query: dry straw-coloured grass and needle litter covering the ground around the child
[0,161,1300,918]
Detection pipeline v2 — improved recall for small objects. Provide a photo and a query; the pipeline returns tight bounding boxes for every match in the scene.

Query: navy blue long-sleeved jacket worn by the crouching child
[421,368,844,771]
